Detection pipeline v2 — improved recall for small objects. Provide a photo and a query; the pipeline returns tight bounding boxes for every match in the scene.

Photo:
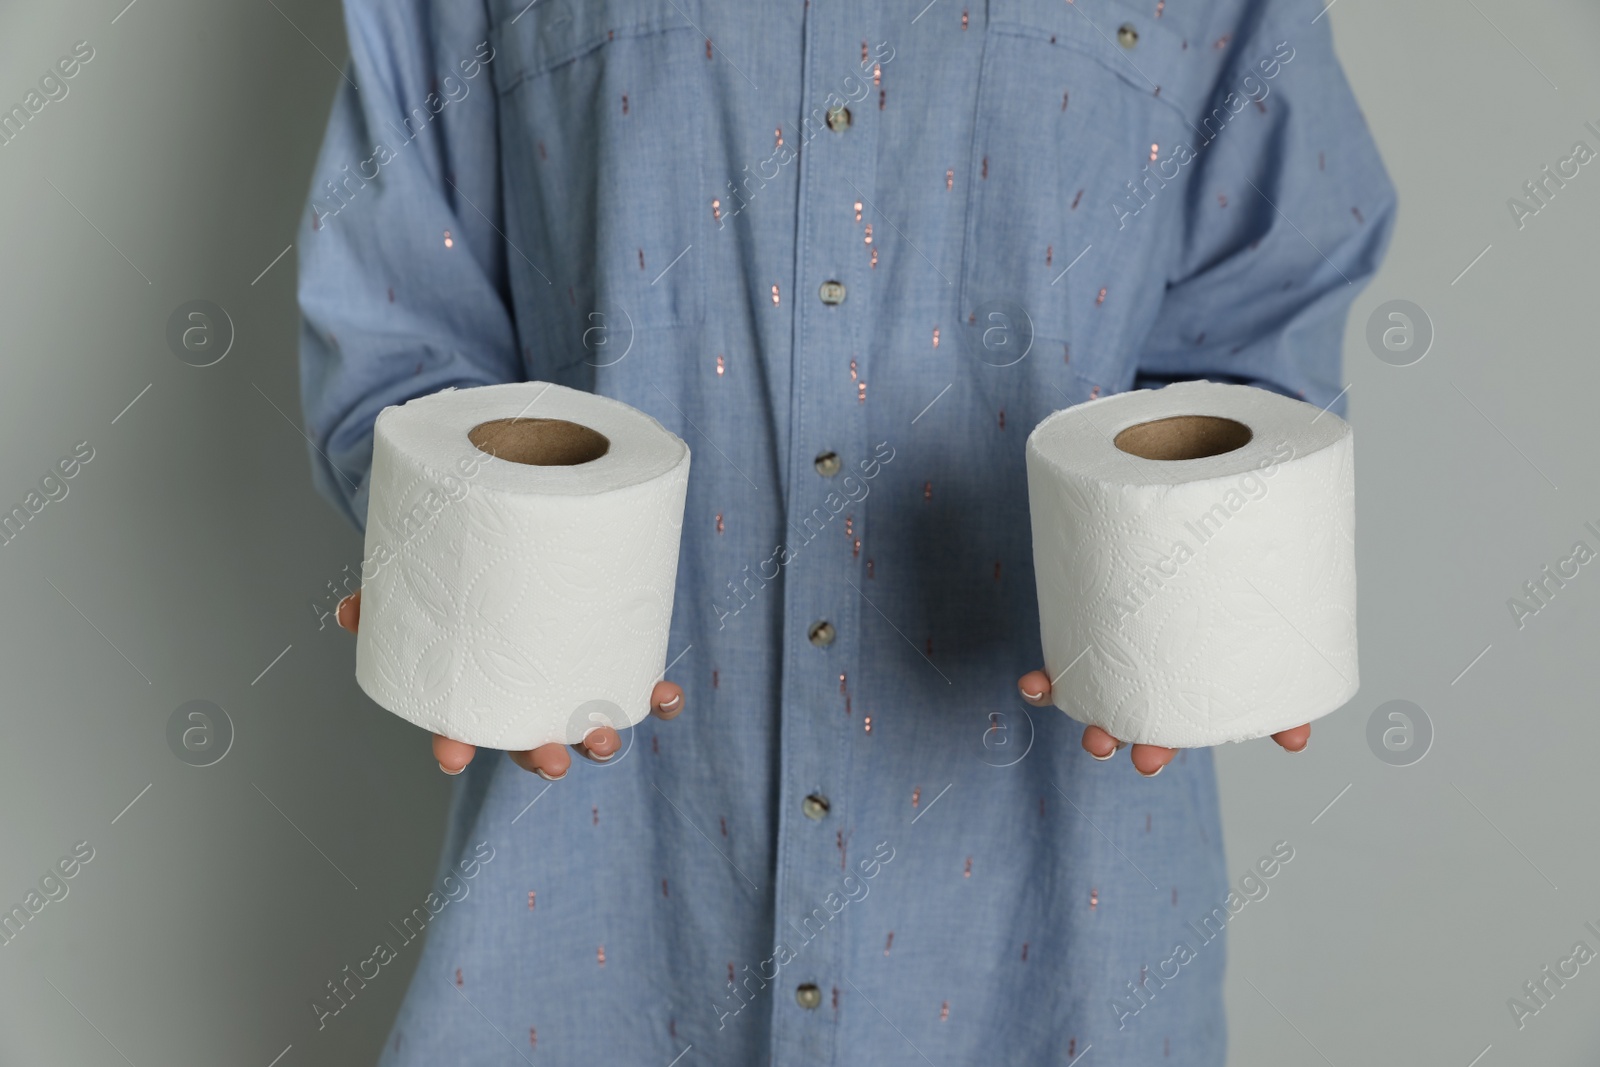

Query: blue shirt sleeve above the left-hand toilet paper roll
[298,0,522,530]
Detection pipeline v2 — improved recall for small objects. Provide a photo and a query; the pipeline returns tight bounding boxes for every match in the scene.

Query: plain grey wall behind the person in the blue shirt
[0,0,1600,1067]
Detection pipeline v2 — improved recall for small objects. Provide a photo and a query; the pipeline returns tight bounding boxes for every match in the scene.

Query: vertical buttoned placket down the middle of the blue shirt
[771,0,882,1067]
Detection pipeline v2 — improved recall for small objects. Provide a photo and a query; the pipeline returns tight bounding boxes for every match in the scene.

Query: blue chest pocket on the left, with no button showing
[491,0,710,373]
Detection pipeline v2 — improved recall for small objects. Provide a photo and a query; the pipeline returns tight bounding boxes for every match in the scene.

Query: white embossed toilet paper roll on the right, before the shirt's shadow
[1027,382,1360,747]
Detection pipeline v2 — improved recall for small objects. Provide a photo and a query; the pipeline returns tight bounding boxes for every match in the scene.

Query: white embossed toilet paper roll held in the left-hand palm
[355,382,690,750]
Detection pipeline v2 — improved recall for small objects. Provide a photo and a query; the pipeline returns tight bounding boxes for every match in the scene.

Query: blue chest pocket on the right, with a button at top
[962,0,1200,363]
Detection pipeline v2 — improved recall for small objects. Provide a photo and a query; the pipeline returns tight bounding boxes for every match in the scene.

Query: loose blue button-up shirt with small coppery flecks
[299,0,1395,1067]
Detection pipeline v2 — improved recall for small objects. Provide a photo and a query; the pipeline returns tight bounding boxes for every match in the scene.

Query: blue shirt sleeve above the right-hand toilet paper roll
[1136,0,1395,414]
